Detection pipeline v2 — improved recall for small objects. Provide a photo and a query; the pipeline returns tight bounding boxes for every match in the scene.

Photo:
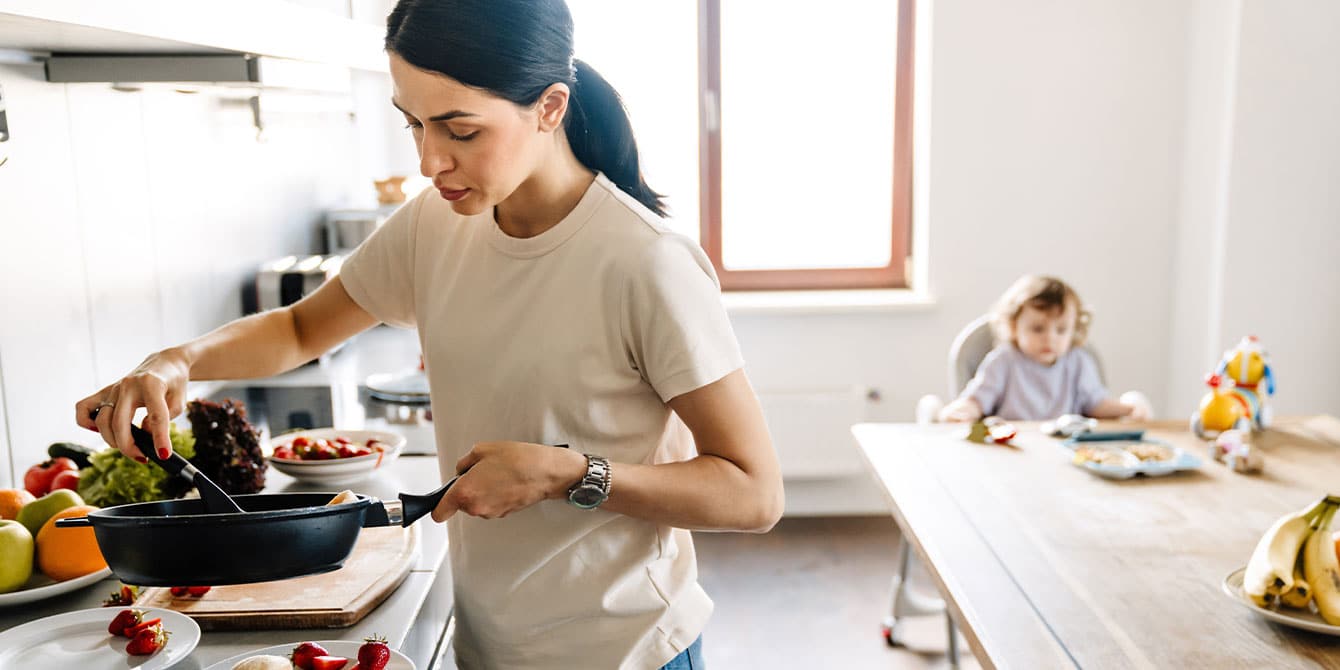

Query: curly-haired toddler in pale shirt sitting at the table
[938,275,1148,422]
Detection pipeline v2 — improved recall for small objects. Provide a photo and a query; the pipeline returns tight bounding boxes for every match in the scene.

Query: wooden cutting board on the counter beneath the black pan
[135,525,419,630]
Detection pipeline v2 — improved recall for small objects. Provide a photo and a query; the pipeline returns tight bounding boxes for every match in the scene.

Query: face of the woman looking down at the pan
[390,54,552,216]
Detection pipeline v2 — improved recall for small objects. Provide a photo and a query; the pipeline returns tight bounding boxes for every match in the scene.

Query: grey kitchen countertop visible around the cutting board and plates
[0,456,454,670]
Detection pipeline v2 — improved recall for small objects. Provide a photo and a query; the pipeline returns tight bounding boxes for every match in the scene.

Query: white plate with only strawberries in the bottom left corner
[0,607,200,670]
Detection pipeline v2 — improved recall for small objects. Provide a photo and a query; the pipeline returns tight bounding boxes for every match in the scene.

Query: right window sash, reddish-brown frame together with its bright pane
[699,0,914,289]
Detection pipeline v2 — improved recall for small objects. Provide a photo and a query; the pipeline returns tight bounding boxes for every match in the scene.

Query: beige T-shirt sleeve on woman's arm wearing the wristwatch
[622,233,744,402]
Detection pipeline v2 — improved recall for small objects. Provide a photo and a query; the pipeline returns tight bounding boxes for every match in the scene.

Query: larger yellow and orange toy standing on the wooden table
[1191,335,1274,440]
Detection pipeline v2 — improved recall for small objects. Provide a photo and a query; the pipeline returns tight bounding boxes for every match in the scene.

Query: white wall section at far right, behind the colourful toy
[1215,0,1340,414]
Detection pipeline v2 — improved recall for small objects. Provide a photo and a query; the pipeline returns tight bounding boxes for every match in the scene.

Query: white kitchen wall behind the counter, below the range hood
[0,64,370,486]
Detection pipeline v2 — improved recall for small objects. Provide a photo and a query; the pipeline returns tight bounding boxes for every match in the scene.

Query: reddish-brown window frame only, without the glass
[698,0,917,291]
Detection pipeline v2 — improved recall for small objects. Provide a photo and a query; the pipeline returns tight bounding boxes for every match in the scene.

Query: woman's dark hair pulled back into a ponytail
[386,0,666,216]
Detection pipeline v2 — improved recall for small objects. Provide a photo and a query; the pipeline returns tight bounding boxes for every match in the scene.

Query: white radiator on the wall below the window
[758,386,872,480]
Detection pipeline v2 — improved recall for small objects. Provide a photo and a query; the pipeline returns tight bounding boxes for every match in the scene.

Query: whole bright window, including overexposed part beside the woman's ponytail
[568,0,914,289]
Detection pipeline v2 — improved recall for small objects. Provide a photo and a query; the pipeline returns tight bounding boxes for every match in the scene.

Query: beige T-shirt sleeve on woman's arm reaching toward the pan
[339,190,427,328]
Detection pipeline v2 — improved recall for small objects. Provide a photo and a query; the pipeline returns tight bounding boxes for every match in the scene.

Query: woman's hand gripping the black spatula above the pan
[75,347,190,462]
